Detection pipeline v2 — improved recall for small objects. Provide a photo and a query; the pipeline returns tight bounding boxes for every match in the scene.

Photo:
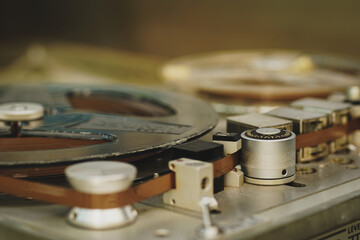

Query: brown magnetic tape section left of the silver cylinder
[0,153,238,209]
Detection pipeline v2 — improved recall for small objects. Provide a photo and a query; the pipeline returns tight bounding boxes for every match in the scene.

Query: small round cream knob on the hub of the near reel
[0,102,44,121]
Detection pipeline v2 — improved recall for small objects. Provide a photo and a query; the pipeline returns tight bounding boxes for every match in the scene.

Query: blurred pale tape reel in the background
[162,50,360,101]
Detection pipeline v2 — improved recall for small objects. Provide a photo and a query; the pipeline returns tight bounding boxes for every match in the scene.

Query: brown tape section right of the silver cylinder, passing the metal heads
[296,118,360,149]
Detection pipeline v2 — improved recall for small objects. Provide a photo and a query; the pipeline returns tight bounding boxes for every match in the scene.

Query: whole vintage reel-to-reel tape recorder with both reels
[0,47,360,239]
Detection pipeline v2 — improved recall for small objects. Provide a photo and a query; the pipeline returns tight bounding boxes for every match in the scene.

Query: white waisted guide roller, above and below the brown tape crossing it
[65,161,137,229]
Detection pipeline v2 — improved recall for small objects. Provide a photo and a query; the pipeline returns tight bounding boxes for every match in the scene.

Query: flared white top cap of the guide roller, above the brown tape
[65,161,136,194]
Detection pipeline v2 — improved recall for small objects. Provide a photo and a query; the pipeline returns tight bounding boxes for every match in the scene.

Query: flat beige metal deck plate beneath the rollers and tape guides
[0,149,360,240]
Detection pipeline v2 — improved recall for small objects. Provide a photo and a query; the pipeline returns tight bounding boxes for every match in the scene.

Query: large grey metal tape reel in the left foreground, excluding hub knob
[0,85,217,166]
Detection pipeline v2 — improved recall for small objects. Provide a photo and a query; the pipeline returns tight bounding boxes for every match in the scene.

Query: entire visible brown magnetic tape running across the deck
[0,113,360,209]
